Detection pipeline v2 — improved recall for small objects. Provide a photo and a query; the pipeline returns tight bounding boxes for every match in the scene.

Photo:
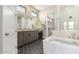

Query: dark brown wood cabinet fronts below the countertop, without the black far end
[17,31,38,46]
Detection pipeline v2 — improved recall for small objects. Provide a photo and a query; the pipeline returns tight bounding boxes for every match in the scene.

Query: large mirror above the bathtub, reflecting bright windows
[47,5,79,30]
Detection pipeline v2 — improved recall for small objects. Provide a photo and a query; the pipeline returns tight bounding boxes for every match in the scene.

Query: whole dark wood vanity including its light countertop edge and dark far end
[17,30,42,46]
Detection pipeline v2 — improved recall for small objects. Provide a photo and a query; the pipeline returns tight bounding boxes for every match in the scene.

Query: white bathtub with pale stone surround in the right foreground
[43,36,79,54]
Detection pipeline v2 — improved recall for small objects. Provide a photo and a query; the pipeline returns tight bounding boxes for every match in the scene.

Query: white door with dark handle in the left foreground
[3,5,17,54]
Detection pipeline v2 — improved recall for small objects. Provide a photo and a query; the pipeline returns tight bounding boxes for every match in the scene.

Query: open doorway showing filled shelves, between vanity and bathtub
[45,14,55,38]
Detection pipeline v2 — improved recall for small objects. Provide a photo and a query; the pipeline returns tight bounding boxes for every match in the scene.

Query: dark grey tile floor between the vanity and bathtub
[18,39,43,54]
